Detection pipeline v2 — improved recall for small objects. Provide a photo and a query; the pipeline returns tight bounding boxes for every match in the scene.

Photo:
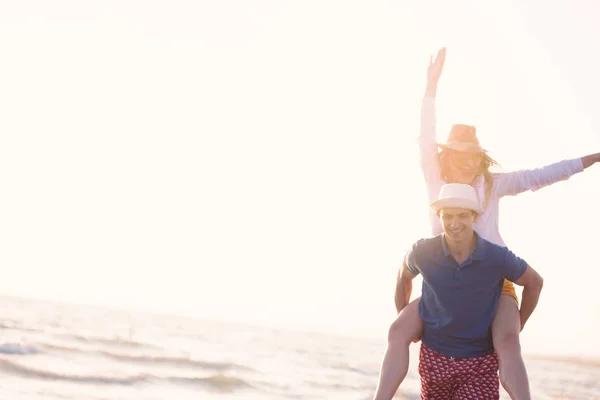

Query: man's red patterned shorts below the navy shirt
[419,343,500,400]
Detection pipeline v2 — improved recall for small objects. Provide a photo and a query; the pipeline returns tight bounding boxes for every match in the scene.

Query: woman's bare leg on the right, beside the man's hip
[492,288,531,400]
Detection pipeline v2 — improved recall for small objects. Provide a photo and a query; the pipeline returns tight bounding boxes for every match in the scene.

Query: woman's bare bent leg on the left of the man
[373,297,423,400]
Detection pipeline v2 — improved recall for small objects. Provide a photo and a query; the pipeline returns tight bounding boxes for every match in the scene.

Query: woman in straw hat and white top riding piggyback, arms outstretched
[374,49,600,400]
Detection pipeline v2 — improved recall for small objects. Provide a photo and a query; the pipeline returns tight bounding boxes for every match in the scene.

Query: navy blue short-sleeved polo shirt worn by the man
[405,233,527,358]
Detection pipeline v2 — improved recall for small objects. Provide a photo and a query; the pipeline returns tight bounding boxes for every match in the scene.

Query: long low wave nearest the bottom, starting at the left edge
[0,359,149,385]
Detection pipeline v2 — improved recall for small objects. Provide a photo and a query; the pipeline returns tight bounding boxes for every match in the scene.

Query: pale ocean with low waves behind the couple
[0,296,600,400]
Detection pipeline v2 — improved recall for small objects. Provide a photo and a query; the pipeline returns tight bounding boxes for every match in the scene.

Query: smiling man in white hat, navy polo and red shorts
[396,184,543,400]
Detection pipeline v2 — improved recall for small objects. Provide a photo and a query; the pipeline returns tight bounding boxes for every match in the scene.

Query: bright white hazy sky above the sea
[0,0,600,356]
